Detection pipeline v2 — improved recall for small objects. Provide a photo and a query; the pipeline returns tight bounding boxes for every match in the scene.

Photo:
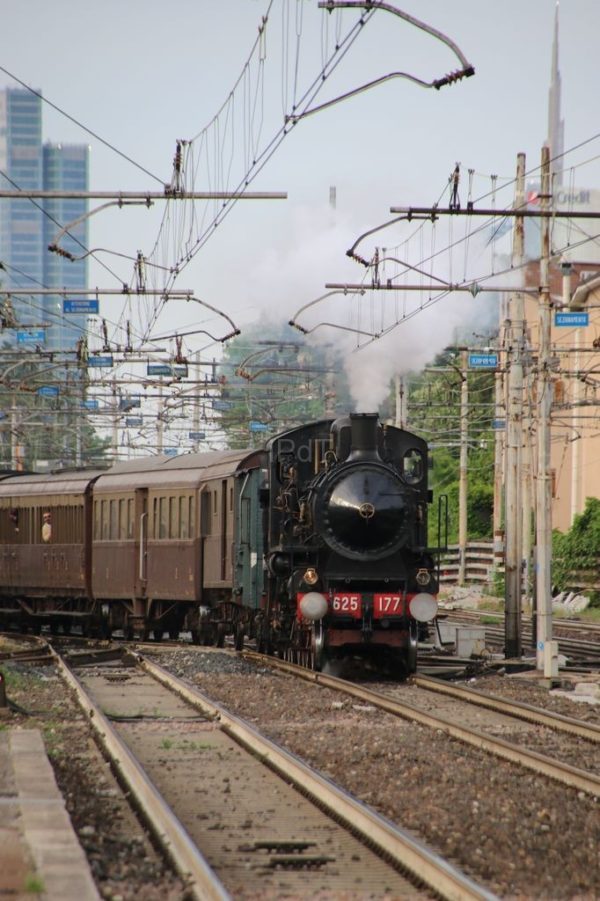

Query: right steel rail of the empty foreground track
[141,655,495,901]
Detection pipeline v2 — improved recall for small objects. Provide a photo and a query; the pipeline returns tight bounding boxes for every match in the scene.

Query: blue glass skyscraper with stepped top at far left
[0,88,89,351]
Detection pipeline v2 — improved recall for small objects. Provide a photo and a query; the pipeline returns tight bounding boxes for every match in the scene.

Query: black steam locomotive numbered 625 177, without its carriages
[264,414,438,673]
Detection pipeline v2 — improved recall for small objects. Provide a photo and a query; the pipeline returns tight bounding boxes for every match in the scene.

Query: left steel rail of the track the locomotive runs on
[241,651,600,798]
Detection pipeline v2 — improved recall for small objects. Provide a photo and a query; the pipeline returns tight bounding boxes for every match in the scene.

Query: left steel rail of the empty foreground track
[56,655,230,901]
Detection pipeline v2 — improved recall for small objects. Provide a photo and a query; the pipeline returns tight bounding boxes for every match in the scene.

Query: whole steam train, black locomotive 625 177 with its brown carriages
[0,414,440,673]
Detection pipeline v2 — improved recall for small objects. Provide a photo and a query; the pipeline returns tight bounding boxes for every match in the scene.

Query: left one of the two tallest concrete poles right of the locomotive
[504,153,525,658]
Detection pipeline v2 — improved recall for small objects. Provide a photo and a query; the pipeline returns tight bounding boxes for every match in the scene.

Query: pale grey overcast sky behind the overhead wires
[0,0,600,406]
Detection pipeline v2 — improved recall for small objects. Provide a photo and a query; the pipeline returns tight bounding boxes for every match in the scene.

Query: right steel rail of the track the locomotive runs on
[412,676,600,742]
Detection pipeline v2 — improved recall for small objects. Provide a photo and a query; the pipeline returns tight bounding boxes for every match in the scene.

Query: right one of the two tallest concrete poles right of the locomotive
[536,145,552,670]
